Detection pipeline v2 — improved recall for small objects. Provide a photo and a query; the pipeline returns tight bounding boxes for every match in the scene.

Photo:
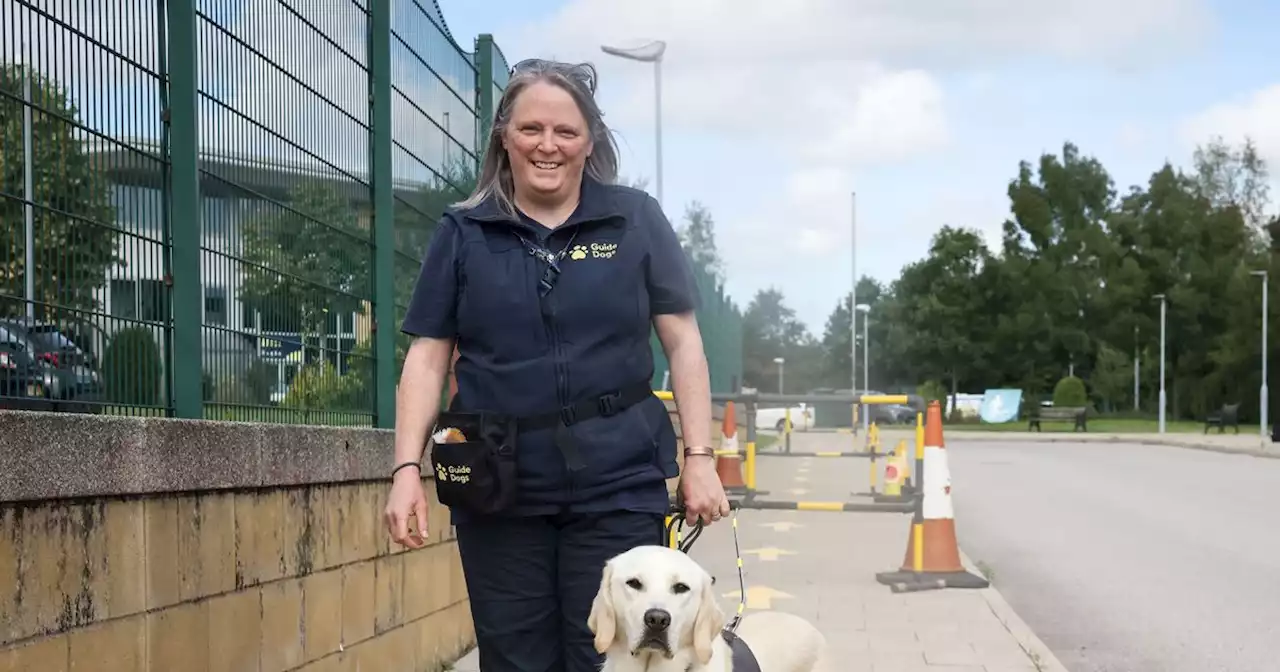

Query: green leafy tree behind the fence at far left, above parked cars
[0,64,122,319]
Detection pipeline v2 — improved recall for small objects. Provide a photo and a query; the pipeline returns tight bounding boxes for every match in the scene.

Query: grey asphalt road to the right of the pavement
[947,436,1280,672]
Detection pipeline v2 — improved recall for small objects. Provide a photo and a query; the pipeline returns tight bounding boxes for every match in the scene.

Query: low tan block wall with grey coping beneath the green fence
[0,411,475,672]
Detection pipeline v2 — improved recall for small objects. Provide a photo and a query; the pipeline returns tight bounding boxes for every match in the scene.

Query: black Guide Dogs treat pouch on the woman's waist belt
[431,411,516,513]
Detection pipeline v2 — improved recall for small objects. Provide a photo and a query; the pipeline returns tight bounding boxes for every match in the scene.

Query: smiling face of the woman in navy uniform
[502,82,591,203]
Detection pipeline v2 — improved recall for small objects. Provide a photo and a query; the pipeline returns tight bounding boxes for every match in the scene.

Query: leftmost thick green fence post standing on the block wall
[165,0,205,419]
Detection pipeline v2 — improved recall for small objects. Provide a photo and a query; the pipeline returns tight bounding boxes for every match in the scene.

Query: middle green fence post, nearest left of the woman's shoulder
[369,0,397,429]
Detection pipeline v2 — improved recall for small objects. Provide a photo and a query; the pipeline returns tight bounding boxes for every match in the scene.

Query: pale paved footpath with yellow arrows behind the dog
[456,434,1066,672]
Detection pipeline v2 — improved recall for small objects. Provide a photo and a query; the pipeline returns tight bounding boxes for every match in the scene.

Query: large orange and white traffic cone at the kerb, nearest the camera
[876,402,991,593]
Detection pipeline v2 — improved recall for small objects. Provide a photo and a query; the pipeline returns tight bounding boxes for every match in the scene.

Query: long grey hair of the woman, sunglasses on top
[458,59,618,218]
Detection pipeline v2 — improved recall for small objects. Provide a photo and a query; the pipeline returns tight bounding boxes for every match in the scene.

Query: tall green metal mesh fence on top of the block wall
[0,0,741,426]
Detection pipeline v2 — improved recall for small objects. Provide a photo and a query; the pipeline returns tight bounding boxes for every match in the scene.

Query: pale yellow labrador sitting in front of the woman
[586,545,833,672]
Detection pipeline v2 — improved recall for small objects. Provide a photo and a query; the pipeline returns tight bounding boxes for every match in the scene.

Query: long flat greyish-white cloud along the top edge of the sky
[504,0,1208,69]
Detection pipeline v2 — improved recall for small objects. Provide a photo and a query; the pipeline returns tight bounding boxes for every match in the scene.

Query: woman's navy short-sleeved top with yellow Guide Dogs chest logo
[402,177,698,524]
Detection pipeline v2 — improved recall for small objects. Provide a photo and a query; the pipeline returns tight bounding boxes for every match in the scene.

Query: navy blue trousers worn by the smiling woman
[457,511,664,672]
